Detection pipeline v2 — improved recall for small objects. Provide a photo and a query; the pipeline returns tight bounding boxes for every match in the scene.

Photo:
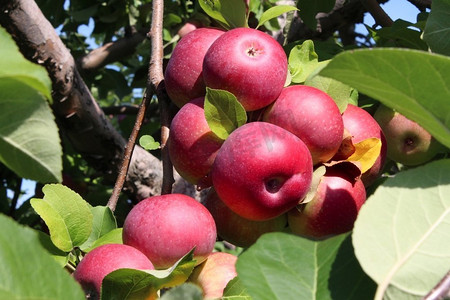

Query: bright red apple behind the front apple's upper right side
[263,85,344,165]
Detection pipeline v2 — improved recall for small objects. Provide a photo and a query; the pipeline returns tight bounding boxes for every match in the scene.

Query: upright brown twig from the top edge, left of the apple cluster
[148,0,174,194]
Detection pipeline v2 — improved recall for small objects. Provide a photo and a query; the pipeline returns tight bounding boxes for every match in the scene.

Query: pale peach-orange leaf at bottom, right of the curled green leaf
[188,252,237,299]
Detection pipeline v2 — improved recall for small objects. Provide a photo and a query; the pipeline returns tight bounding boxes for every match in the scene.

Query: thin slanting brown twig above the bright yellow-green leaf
[107,93,151,211]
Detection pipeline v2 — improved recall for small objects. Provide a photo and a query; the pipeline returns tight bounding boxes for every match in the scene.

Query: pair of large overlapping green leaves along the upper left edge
[0,28,62,183]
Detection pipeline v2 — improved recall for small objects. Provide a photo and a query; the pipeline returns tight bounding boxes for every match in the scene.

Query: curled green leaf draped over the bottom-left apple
[101,250,195,300]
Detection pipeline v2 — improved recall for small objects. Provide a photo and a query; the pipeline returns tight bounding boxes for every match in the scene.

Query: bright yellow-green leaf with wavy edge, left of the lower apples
[31,184,93,252]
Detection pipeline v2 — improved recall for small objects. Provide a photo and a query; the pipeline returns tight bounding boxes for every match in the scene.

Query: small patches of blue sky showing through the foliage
[11,0,426,206]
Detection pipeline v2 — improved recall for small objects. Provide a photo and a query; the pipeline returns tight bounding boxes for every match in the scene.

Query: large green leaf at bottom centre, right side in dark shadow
[236,232,375,300]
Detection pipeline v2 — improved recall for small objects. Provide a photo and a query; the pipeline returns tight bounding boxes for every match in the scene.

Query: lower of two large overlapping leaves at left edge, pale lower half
[0,77,62,183]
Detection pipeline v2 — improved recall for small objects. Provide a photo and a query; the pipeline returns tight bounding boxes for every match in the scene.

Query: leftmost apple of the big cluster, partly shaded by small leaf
[168,97,223,188]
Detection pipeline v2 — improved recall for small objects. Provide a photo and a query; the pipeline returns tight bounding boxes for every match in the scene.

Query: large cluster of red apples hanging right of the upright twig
[165,28,386,247]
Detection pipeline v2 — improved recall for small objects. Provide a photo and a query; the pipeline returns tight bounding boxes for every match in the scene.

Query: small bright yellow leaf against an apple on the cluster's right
[347,138,381,173]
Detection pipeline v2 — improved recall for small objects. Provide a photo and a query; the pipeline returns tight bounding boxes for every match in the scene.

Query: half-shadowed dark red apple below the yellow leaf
[288,169,366,239]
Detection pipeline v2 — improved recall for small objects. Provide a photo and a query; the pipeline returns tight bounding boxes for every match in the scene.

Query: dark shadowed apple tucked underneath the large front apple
[203,188,287,248]
